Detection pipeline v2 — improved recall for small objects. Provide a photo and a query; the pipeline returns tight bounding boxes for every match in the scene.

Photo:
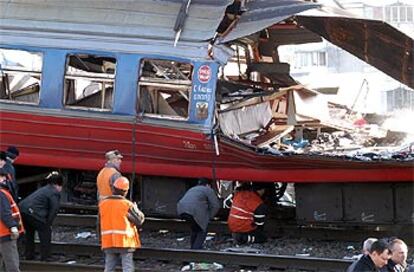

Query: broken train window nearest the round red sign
[136,58,194,121]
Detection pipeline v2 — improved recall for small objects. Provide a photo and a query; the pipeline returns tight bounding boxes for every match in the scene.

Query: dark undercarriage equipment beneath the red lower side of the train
[13,166,414,230]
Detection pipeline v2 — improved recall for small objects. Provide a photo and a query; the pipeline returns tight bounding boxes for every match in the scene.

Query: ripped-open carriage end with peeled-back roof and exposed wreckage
[212,1,414,161]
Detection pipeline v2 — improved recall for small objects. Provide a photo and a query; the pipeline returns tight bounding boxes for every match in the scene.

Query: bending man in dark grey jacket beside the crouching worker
[177,178,220,249]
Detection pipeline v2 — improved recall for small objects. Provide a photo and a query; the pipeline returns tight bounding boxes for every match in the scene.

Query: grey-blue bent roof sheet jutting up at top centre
[220,0,320,43]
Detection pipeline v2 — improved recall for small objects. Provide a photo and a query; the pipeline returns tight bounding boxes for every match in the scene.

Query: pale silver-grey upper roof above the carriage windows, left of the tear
[0,0,233,42]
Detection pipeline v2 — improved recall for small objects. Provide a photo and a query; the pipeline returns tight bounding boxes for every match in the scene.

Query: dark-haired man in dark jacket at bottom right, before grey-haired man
[351,240,391,272]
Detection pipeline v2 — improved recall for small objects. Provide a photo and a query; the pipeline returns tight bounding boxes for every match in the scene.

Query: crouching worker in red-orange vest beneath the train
[227,183,267,244]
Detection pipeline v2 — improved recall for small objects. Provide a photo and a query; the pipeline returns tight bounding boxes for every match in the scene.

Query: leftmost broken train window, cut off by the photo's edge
[0,47,44,106]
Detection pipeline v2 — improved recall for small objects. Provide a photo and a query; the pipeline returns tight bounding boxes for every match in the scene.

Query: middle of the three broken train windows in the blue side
[63,52,118,112]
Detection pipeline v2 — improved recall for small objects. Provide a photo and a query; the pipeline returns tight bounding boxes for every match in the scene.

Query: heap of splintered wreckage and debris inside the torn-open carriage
[218,83,414,161]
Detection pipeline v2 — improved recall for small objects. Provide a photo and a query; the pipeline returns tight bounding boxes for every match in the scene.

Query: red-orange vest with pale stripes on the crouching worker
[227,191,263,233]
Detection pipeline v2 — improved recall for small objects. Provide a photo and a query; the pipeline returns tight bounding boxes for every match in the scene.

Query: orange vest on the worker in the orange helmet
[99,197,141,249]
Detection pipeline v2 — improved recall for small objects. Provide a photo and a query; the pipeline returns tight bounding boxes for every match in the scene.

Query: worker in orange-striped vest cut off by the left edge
[0,168,24,272]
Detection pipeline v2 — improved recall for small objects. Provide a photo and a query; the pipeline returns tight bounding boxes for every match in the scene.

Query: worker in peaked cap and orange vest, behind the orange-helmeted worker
[96,150,123,201]
